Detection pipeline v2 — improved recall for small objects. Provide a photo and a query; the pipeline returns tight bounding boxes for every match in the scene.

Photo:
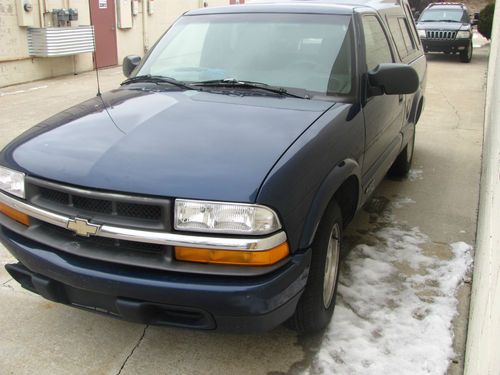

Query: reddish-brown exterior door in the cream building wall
[90,0,118,68]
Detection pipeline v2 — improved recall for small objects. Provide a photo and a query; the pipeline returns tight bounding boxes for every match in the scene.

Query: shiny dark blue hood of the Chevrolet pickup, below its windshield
[0,85,332,202]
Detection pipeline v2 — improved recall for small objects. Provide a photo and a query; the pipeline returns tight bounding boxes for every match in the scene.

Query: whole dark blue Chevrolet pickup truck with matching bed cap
[0,0,426,332]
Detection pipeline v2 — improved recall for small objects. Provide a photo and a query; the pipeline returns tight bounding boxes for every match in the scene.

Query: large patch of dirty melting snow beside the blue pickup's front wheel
[306,213,472,375]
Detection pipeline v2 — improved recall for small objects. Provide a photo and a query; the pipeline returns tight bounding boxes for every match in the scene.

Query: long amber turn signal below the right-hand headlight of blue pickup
[175,242,290,266]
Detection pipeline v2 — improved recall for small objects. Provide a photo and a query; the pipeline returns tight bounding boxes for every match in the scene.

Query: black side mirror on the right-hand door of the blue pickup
[368,64,420,96]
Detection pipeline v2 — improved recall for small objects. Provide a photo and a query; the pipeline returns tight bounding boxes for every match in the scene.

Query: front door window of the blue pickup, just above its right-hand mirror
[362,16,394,70]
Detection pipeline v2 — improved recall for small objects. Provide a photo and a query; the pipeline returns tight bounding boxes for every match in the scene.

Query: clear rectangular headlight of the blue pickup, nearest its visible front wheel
[174,199,281,235]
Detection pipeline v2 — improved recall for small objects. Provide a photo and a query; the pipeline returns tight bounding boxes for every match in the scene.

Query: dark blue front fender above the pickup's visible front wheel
[257,103,365,252]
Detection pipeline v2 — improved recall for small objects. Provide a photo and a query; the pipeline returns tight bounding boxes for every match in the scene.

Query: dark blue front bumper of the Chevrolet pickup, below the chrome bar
[0,226,311,332]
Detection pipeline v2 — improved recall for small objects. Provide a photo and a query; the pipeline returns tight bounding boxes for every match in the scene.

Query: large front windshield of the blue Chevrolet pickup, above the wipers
[137,13,354,95]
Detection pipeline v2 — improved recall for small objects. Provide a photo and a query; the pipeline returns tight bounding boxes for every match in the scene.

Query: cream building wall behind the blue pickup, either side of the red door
[0,0,229,87]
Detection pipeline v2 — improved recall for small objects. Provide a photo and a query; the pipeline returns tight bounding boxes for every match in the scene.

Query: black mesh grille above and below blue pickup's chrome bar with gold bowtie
[21,177,172,268]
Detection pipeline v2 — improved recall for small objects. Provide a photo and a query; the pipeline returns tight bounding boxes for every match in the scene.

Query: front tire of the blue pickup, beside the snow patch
[286,201,342,334]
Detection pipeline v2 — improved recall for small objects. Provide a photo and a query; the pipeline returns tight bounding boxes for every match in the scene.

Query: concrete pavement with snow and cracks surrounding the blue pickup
[0,38,488,374]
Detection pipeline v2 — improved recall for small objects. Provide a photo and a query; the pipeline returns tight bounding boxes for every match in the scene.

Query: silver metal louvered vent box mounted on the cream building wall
[28,26,94,57]
